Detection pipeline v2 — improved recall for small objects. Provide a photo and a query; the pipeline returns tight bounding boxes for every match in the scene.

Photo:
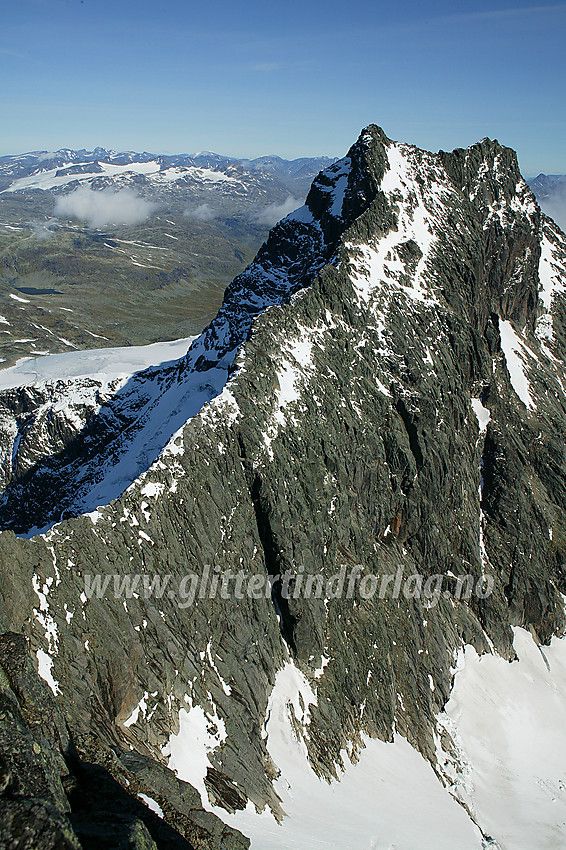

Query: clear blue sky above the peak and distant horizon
[0,0,566,175]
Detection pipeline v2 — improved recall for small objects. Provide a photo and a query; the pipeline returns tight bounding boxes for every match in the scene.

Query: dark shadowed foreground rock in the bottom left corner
[0,632,249,850]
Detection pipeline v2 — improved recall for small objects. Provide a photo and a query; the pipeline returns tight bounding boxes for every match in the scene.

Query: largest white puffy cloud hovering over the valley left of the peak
[54,186,157,227]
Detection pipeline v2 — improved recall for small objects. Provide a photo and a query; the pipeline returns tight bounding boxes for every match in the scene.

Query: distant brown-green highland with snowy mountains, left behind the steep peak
[0,148,338,366]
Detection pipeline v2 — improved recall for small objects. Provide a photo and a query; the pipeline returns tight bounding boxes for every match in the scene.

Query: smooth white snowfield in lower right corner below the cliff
[441,629,566,850]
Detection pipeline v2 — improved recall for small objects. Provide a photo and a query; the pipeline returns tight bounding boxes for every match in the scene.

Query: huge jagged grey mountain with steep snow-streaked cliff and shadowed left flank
[0,126,566,847]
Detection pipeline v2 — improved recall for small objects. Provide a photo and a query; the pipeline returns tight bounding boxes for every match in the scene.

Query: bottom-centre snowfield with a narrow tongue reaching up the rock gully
[220,663,482,850]
